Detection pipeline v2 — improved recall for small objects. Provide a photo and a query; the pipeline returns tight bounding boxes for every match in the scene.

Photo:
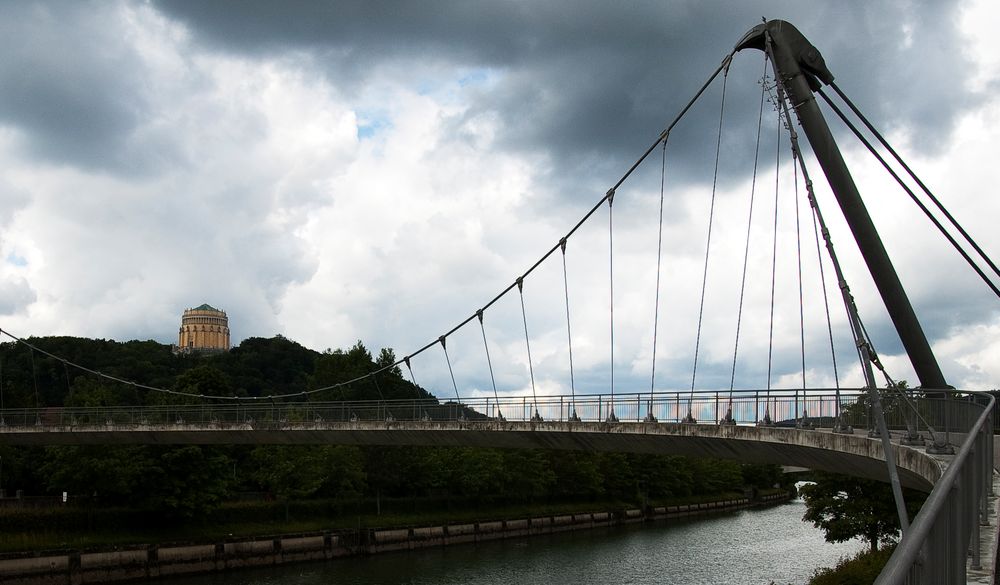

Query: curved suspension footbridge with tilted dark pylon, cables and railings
[0,21,1000,583]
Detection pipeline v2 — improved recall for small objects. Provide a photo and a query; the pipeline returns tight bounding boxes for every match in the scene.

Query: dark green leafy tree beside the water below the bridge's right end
[799,471,923,551]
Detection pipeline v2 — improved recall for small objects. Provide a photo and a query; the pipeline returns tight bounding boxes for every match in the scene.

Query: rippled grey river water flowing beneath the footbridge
[161,500,866,585]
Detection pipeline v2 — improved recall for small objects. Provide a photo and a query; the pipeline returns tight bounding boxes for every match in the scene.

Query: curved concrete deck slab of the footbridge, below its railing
[0,420,948,491]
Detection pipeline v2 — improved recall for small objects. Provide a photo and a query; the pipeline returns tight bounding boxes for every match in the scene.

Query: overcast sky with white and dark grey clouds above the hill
[0,0,1000,396]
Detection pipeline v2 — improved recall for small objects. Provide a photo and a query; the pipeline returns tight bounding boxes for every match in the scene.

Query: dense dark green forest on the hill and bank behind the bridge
[0,336,781,520]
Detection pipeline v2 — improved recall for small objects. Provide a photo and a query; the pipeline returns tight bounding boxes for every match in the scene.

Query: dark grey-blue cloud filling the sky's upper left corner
[0,2,180,174]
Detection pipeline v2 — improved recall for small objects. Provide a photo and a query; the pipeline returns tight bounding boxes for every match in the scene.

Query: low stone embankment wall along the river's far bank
[0,493,792,585]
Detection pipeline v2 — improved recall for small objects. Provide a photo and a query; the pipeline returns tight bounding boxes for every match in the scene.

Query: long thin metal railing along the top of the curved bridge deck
[0,389,981,435]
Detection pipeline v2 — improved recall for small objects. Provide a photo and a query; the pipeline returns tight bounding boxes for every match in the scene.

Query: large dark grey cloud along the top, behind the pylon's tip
[157,0,971,191]
